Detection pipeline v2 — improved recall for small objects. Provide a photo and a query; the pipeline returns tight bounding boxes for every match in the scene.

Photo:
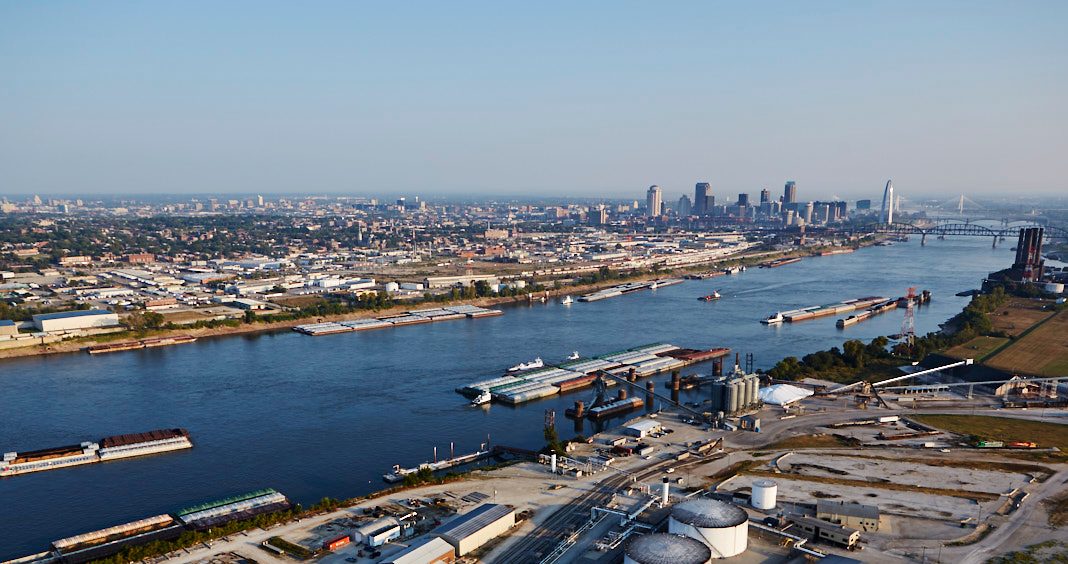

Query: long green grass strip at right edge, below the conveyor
[910,416,1068,451]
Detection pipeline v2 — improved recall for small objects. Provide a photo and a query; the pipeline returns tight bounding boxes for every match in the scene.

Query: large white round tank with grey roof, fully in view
[668,498,749,559]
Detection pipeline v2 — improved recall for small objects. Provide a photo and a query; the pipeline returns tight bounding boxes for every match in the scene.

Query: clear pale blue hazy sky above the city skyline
[0,0,1068,200]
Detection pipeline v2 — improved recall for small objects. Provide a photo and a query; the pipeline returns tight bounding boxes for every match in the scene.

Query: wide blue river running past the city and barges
[0,238,1012,559]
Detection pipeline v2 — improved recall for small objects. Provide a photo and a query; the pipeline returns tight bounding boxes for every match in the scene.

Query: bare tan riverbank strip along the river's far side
[0,240,876,360]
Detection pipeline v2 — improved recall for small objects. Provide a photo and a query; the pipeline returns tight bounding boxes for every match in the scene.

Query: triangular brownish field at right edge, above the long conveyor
[985,310,1068,376]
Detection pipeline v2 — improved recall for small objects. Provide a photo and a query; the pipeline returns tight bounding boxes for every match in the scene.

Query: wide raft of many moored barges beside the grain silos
[456,343,731,405]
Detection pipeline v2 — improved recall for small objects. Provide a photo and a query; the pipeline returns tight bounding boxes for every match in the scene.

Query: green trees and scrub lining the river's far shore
[0,238,879,361]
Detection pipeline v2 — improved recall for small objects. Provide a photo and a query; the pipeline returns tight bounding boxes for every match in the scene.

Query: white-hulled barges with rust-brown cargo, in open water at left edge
[0,428,193,476]
